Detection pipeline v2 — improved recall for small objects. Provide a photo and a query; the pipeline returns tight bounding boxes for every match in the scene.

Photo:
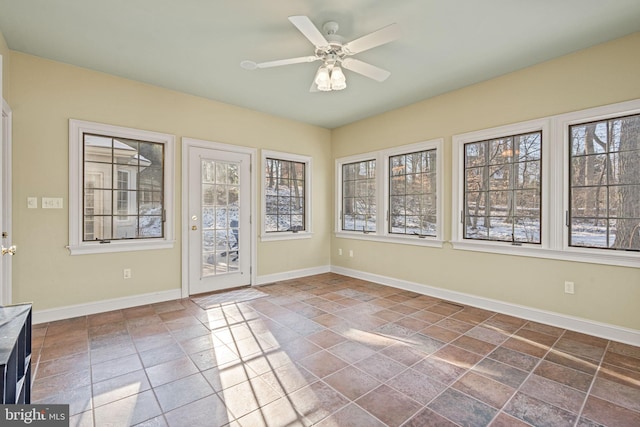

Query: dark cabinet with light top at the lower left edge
[0,304,31,404]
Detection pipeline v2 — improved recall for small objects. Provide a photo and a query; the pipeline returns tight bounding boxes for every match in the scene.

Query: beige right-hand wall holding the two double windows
[331,33,640,330]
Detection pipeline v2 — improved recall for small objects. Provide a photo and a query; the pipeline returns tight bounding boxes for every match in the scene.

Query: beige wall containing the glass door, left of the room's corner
[10,52,333,310]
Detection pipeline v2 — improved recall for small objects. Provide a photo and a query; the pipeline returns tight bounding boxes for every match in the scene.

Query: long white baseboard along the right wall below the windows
[331,266,640,346]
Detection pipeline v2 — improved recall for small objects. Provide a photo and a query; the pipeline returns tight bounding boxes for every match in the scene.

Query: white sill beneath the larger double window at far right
[451,241,640,268]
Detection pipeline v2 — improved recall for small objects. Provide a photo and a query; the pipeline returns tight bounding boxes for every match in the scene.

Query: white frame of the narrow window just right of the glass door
[260,150,313,242]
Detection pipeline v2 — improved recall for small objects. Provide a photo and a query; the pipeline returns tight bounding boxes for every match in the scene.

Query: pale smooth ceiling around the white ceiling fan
[0,0,640,128]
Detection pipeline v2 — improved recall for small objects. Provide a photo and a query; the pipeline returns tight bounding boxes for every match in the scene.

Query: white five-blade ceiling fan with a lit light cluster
[240,16,400,92]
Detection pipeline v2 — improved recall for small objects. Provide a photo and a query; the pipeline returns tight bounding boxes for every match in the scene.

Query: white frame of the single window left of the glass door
[67,119,175,255]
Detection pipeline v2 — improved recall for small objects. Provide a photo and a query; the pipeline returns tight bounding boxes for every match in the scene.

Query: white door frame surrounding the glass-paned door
[180,137,258,298]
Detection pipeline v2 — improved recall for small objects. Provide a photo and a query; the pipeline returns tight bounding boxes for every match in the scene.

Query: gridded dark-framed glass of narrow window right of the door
[264,157,306,233]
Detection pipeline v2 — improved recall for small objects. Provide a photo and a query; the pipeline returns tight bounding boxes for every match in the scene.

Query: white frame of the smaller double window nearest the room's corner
[334,138,444,248]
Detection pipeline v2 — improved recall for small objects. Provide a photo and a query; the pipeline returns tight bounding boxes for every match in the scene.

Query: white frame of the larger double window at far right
[450,100,640,267]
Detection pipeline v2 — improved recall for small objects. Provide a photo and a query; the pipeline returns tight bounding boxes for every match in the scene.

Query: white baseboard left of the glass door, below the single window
[33,289,182,325]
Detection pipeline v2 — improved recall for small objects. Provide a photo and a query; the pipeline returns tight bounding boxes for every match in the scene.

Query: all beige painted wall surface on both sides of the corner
[6,34,640,330]
